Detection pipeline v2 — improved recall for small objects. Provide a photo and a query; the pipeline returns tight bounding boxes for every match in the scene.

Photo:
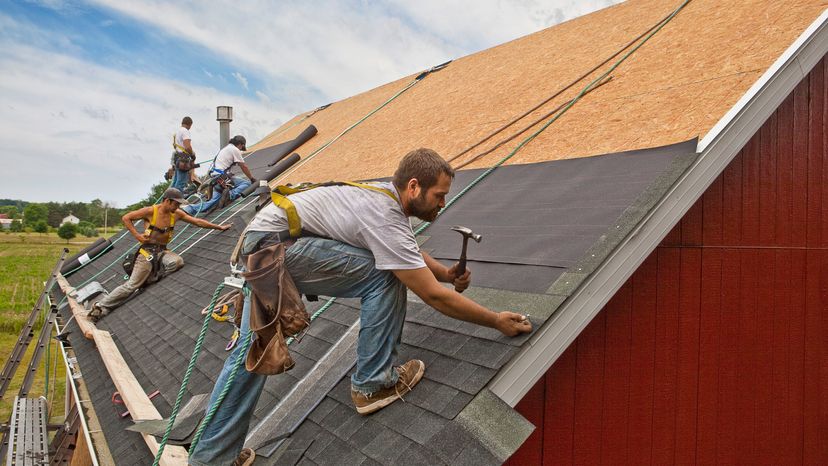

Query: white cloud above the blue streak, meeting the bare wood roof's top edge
[90,0,618,104]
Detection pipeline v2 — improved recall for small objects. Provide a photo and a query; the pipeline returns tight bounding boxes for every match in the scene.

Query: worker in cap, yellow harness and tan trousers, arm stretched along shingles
[89,188,230,322]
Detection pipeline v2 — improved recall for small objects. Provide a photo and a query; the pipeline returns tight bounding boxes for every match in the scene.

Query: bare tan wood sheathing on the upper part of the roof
[244,0,828,186]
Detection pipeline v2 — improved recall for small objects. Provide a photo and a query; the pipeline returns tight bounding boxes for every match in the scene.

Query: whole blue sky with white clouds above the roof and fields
[0,0,619,207]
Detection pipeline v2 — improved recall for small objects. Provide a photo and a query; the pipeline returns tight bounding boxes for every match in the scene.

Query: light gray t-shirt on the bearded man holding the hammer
[247,183,426,270]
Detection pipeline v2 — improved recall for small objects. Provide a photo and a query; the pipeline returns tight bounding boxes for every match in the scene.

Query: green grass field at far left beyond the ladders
[0,233,95,422]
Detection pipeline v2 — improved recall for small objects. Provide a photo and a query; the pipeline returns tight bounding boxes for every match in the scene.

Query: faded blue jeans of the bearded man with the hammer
[190,238,406,466]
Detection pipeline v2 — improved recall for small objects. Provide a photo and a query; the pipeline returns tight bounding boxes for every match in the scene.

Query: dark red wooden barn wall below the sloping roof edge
[509,58,828,465]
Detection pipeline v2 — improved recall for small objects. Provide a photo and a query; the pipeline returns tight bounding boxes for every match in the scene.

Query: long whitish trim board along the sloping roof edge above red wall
[488,10,828,407]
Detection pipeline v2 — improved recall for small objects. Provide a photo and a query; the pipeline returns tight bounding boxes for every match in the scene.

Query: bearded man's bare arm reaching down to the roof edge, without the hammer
[394,266,532,337]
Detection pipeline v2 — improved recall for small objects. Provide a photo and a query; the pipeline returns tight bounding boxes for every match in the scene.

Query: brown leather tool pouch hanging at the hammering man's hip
[242,243,310,375]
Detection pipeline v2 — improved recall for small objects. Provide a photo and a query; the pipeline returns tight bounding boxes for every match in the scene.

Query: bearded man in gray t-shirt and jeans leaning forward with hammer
[190,149,532,465]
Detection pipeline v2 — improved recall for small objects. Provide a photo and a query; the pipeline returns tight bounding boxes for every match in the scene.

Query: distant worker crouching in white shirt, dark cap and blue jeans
[183,135,256,215]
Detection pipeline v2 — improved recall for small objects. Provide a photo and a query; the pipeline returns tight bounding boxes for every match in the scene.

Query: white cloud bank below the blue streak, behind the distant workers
[0,22,292,206]
